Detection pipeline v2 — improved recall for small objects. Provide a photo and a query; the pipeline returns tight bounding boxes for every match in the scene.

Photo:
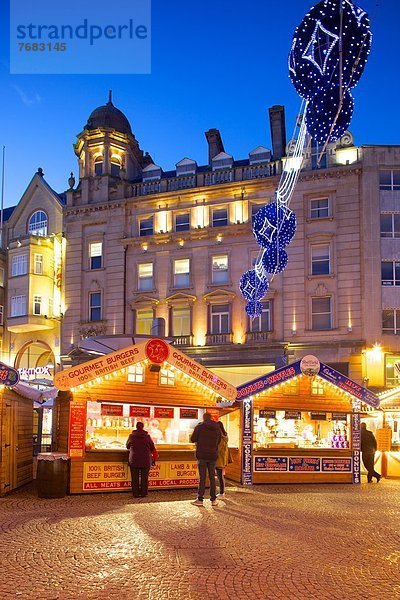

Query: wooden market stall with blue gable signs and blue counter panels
[230,356,379,485]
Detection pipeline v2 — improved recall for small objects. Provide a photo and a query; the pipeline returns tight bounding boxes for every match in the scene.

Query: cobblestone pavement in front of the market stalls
[0,480,400,600]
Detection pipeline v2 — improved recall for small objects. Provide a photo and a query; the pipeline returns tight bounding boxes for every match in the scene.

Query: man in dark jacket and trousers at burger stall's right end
[190,412,221,506]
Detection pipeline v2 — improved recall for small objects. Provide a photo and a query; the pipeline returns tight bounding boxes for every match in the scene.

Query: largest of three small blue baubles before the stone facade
[253,202,296,248]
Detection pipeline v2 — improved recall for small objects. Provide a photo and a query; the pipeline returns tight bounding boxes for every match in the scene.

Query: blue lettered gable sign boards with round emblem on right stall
[237,355,379,408]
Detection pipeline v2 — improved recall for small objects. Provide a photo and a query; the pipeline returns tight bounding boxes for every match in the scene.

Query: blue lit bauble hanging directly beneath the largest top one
[306,88,354,144]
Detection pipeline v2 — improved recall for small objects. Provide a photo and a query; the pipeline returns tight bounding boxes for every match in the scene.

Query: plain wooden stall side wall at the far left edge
[0,384,33,496]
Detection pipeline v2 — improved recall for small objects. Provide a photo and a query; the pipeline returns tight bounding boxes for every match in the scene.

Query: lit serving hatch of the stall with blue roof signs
[253,409,350,450]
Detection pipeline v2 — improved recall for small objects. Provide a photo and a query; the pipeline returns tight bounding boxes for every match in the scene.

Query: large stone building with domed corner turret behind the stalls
[57,98,400,387]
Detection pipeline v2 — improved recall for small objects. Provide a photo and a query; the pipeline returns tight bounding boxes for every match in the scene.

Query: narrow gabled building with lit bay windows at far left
[0,169,65,385]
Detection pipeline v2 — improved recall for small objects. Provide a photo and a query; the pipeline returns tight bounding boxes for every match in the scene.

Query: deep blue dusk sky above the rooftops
[0,0,400,206]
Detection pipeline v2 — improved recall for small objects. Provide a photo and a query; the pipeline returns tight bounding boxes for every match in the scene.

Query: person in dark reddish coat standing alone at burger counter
[126,421,157,498]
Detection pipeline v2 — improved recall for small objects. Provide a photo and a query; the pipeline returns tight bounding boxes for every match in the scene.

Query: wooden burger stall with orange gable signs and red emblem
[55,338,237,493]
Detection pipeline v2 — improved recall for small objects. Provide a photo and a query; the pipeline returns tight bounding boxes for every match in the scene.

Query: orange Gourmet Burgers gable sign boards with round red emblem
[54,338,237,402]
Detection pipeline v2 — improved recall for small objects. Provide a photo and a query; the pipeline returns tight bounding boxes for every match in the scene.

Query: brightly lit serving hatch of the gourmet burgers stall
[85,401,203,450]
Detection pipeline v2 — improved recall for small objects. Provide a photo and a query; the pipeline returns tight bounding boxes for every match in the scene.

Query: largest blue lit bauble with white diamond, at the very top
[289,0,372,100]
